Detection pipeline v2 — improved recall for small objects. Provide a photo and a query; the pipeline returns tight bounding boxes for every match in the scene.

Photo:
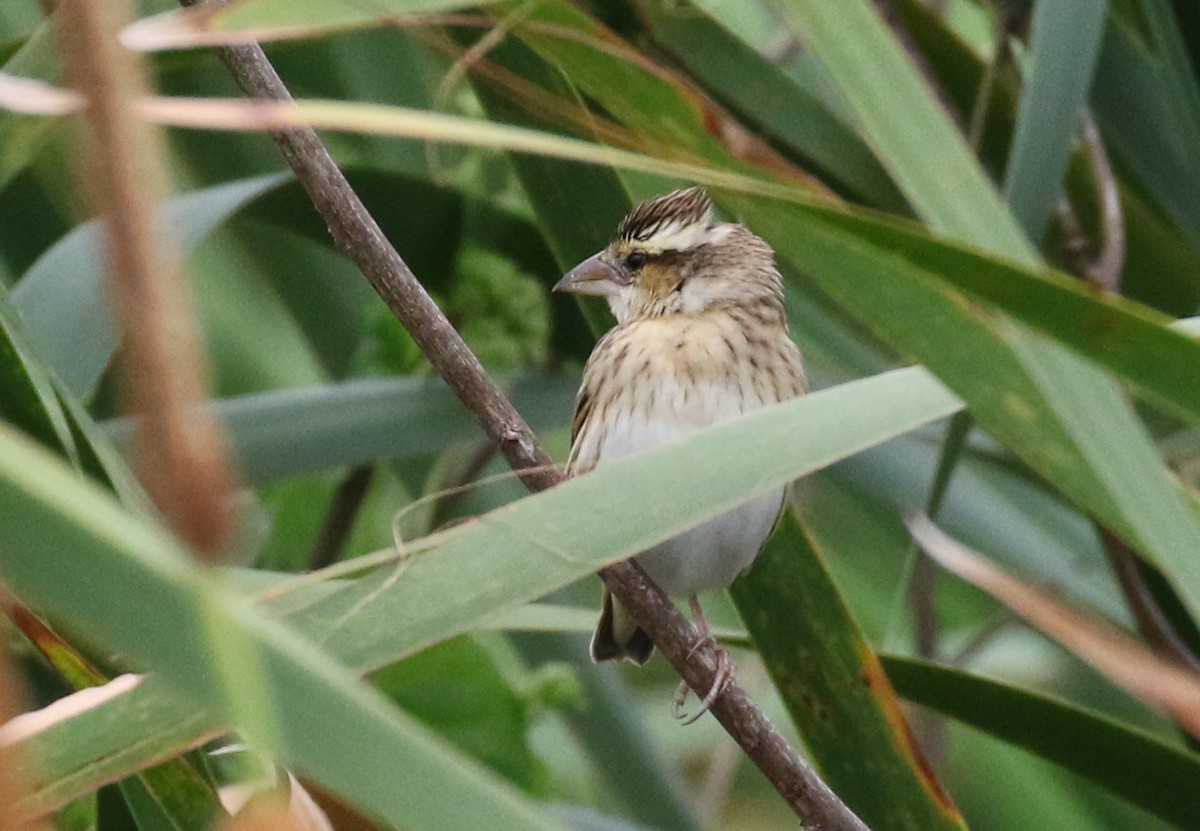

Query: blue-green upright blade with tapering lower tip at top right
[1004,0,1108,240]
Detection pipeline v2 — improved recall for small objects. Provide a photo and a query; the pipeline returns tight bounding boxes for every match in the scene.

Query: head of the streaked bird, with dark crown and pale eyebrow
[554,187,782,323]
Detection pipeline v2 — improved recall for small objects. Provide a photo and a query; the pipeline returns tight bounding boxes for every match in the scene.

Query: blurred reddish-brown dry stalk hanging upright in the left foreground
[59,0,234,555]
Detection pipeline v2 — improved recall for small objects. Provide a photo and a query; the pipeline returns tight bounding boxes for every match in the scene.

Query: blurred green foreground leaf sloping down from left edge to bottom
[0,422,560,831]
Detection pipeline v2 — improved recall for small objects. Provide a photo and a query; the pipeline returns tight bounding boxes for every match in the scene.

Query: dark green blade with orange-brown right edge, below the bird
[732,510,966,831]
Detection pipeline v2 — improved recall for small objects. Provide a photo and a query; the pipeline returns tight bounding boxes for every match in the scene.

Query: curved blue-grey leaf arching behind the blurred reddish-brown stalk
[11,174,286,399]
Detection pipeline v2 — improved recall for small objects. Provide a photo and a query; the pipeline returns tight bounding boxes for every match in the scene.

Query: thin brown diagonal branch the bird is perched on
[180,0,866,831]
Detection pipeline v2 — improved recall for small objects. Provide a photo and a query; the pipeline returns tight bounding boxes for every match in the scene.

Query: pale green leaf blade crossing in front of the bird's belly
[265,369,958,668]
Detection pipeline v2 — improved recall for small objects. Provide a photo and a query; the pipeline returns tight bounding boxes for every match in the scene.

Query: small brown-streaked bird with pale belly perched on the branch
[554,187,805,716]
